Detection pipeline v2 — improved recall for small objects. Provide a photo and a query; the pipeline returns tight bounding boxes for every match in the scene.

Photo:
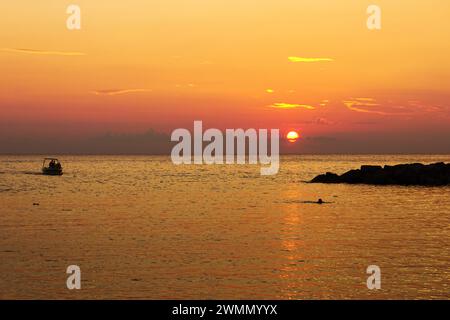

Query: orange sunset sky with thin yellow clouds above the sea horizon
[0,0,450,153]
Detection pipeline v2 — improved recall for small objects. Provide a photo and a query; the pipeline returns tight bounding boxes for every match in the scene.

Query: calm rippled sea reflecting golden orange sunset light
[0,155,450,299]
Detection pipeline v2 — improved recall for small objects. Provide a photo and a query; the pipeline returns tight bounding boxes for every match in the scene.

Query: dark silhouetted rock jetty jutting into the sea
[311,162,450,186]
